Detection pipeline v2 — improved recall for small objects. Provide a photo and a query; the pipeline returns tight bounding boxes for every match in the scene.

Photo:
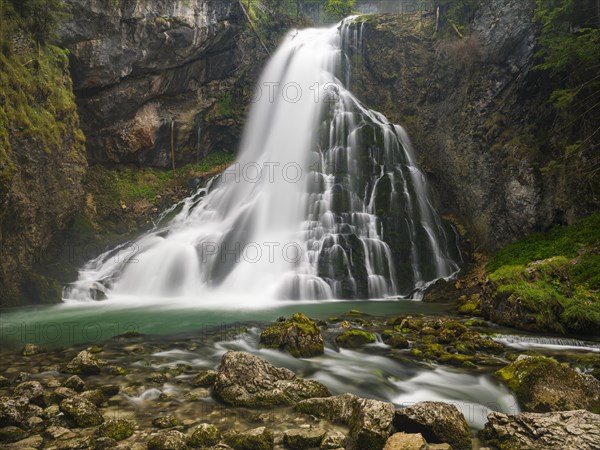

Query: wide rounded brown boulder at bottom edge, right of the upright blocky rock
[394,402,472,449]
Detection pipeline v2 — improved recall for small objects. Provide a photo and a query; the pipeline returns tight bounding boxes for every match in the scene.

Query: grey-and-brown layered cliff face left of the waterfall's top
[60,0,266,167]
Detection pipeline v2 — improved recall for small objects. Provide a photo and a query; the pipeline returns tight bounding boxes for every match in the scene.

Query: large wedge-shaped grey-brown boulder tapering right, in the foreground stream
[213,351,331,407]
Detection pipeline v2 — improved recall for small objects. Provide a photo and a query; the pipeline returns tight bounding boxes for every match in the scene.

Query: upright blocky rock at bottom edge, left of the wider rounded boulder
[349,399,395,449]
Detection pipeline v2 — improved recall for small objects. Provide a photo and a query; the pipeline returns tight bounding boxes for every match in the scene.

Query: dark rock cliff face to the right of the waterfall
[354,0,597,251]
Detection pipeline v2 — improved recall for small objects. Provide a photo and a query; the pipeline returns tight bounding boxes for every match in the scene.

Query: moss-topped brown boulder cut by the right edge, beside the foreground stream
[496,355,600,413]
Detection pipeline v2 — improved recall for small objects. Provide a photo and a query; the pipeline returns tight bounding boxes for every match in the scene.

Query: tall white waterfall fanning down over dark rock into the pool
[66,18,458,306]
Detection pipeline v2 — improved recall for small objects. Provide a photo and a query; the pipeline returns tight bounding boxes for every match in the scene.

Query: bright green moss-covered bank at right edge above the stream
[488,214,600,334]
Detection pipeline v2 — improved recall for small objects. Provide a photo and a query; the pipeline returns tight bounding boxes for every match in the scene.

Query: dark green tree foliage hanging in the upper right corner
[535,0,600,179]
